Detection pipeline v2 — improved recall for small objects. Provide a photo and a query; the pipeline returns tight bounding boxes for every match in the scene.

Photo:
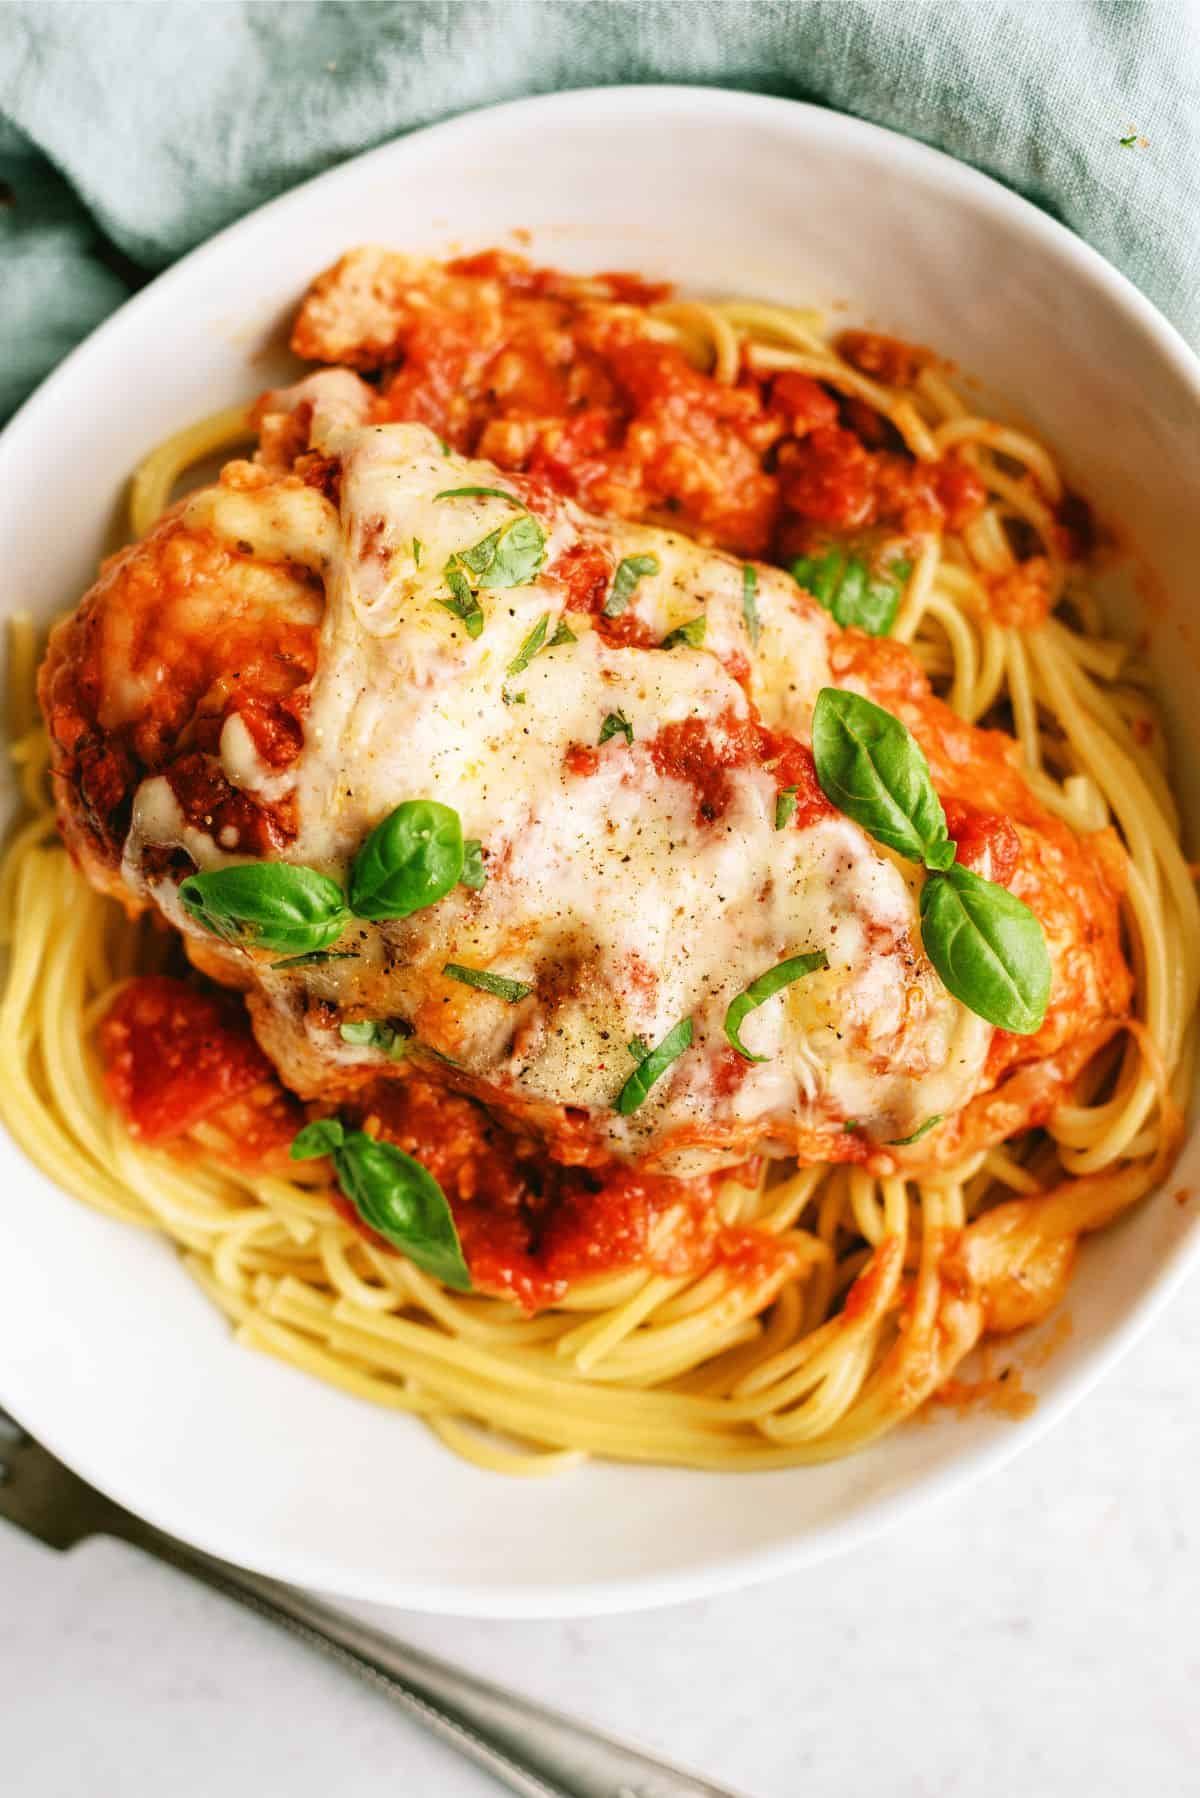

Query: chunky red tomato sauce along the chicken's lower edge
[99,975,781,1311]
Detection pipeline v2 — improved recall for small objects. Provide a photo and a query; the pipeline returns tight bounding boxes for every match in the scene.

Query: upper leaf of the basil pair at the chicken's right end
[813,687,948,861]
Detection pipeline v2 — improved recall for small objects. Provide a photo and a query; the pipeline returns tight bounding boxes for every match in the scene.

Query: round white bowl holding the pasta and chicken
[0,88,1200,1616]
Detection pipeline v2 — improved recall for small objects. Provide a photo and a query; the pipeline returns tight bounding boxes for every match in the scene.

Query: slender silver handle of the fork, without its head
[121,1516,738,1798]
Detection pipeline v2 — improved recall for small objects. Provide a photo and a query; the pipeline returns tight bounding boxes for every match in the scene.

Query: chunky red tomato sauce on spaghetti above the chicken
[293,250,993,557]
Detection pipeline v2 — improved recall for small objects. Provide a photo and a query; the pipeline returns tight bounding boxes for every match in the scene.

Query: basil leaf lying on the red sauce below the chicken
[338,1131,471,1293]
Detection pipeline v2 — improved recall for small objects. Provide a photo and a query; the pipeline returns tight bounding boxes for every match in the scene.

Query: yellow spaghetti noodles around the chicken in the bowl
[0,269,1200,1474]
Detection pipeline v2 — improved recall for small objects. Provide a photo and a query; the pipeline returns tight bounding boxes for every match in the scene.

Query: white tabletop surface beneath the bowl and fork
[0,1280,1200,1798]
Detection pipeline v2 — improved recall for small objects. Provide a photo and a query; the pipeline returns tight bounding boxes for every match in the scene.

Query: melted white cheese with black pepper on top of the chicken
[134,405,991,1169]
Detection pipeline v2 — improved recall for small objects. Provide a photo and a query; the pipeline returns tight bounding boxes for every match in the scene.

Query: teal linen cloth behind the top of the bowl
[0,0,1200,419]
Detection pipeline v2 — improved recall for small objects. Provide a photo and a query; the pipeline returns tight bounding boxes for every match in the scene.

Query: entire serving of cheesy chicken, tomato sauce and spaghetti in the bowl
[7,248,1195,1467]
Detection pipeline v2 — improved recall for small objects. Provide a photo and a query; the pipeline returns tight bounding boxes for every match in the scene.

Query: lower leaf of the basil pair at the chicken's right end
[921,865,1051,1036]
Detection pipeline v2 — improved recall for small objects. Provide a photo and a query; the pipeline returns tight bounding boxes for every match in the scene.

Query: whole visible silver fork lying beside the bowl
[0,1411,738,1798]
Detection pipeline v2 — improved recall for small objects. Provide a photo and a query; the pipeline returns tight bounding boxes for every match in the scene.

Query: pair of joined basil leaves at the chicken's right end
[813,687,1051,1036]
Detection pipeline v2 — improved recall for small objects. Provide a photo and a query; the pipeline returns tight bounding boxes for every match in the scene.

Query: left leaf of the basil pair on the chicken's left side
[180,861,349,955]
